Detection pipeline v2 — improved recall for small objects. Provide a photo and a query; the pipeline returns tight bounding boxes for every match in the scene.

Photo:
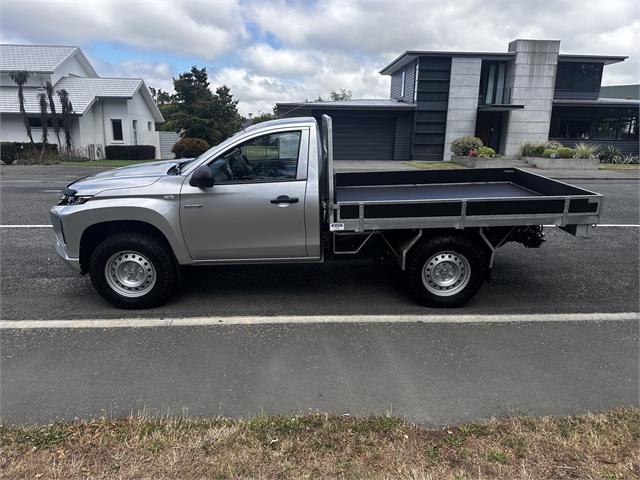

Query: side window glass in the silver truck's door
[209,130,302,183]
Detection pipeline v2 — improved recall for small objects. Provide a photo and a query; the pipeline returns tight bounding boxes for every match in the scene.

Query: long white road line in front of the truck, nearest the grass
[0,312,640,330]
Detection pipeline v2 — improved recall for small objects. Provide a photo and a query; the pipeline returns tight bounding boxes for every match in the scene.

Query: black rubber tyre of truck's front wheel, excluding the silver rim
[89,233,178,309]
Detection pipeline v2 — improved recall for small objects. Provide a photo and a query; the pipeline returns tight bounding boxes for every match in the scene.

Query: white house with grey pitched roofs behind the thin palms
[0,44,178,158]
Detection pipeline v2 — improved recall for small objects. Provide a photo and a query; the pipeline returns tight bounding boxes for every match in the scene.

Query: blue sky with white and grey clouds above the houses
[0,0,640,115]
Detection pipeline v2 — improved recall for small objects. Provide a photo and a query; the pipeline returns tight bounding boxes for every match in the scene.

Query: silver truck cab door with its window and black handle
[180,128,309,260]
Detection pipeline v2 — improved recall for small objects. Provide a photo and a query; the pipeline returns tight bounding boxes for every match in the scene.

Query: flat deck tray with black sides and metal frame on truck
[334,168,602,231]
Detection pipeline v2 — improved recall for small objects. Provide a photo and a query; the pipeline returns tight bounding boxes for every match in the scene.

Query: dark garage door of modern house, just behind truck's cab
[333,116,396,160]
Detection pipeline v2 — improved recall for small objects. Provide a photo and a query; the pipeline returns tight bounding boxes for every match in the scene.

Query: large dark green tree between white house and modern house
[158,66,242,145]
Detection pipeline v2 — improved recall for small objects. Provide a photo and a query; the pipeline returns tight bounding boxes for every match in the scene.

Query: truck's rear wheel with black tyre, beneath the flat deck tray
[405,235,488,308]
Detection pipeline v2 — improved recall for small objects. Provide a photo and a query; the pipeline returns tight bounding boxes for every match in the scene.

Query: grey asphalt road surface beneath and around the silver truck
[0,167,640,423]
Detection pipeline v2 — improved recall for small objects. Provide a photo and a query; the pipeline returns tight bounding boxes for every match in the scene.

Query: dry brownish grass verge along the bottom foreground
[0,409,640,480]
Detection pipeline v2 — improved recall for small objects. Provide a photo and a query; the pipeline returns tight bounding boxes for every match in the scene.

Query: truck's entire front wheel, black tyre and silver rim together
[89,233,178,309]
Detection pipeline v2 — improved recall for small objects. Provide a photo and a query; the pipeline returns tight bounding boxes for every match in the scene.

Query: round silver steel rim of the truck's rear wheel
[422,251,471,297]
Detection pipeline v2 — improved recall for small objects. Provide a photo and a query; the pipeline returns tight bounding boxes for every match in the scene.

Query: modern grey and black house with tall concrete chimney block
[277,40,640,160]
